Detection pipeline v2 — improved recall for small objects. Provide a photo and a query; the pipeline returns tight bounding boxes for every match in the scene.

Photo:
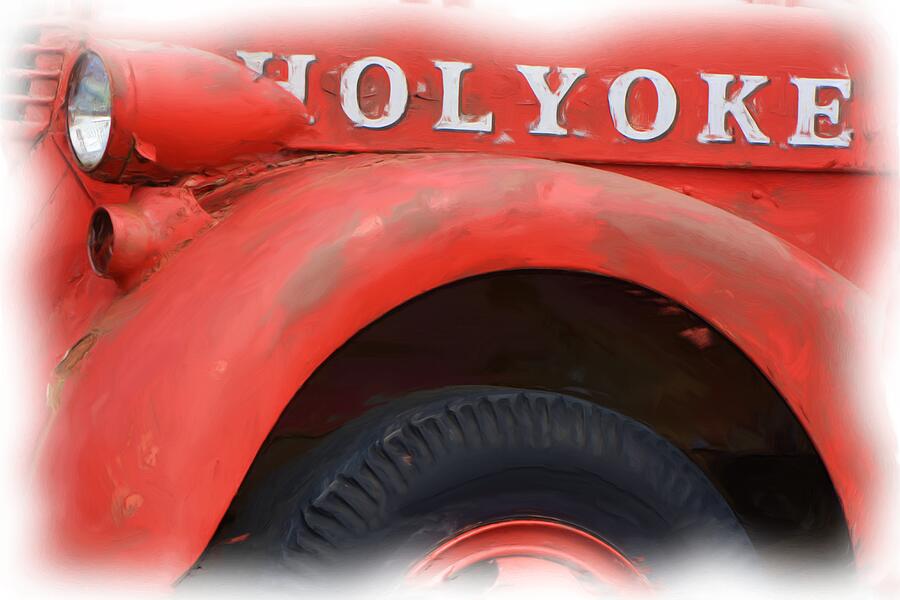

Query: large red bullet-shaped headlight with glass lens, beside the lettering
[59,39,310,183]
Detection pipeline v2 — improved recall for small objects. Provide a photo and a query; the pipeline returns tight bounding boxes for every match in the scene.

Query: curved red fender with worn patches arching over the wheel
[41,154,884,581]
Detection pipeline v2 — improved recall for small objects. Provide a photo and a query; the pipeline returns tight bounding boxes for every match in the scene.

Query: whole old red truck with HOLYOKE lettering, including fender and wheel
[7,2,897,587]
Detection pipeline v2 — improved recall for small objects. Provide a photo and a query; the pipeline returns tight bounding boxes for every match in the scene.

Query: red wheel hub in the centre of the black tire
[407,519,648,593]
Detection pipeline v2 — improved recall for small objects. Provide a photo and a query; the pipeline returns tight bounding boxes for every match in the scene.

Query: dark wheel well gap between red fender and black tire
[217,270,852,564]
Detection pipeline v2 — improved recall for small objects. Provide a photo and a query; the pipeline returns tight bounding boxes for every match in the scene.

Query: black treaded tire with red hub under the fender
[195,387,751,591]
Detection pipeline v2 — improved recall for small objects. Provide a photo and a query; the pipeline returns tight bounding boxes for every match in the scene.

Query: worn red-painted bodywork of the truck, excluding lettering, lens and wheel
[7,0,897,581]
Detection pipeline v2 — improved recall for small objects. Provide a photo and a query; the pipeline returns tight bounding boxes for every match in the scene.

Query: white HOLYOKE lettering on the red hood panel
[236,50,853,154]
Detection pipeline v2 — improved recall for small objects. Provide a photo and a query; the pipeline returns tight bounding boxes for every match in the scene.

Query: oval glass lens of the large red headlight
[68,52,112,169]
